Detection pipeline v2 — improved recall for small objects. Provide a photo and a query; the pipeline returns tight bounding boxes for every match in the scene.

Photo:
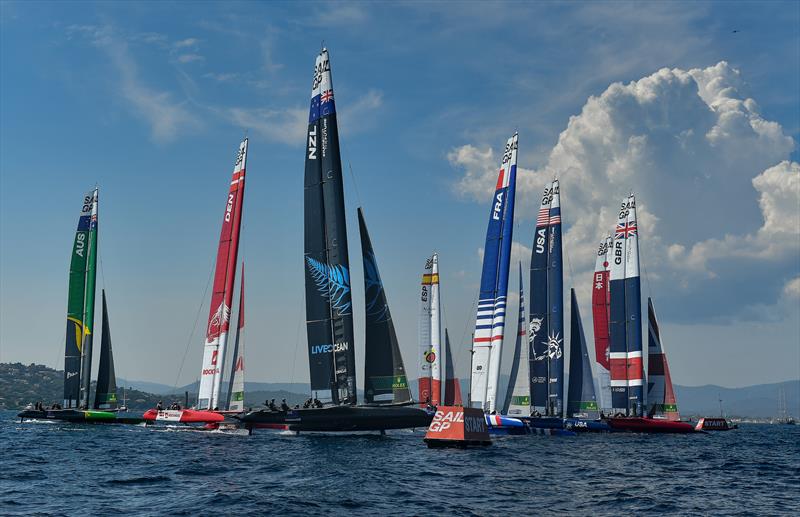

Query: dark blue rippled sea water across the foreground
[0,412,800,515]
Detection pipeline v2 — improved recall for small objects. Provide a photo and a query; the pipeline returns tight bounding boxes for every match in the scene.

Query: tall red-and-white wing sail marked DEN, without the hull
[197,138,247,409]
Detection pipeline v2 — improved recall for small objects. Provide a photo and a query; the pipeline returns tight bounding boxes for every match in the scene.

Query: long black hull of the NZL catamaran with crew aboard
[239,406,433,433]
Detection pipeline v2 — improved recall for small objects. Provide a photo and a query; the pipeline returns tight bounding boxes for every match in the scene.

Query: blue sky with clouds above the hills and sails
[0,1,800,387]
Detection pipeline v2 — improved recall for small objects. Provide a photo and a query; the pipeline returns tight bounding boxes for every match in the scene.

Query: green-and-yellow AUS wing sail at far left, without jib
[64,189,97,408]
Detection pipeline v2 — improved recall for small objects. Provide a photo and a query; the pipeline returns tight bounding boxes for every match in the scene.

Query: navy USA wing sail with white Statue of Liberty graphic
[528,180,564,417]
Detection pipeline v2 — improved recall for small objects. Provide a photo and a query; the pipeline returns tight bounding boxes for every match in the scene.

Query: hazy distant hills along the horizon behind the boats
[0,363,800,418]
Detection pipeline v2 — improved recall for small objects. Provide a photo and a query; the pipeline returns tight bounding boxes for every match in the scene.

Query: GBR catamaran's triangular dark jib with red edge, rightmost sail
[647,298,680,421]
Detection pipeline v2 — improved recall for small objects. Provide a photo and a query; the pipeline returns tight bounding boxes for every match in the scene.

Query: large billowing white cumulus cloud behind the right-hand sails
[448,61,800,318]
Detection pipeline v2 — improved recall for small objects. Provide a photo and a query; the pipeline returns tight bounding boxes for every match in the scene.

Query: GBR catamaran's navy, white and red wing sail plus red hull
[608,194,694,433]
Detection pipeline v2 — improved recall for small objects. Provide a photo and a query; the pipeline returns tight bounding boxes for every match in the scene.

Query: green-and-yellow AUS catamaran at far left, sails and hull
[18,187,138,422]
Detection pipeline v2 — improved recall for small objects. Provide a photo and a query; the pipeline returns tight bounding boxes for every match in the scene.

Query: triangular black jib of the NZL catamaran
[358,208,411,403]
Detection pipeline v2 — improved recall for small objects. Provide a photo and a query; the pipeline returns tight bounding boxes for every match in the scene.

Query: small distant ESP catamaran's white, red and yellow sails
[419,253,463,407]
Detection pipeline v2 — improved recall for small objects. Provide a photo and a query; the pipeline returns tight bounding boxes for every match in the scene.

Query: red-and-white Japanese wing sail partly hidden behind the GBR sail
[592,236,614,408]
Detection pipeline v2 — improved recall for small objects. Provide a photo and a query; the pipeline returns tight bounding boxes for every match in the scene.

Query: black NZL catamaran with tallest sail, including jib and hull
[241,48,432,432]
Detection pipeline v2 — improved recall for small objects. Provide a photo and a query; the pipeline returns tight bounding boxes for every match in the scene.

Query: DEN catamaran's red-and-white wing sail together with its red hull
[144,138,248,423]
